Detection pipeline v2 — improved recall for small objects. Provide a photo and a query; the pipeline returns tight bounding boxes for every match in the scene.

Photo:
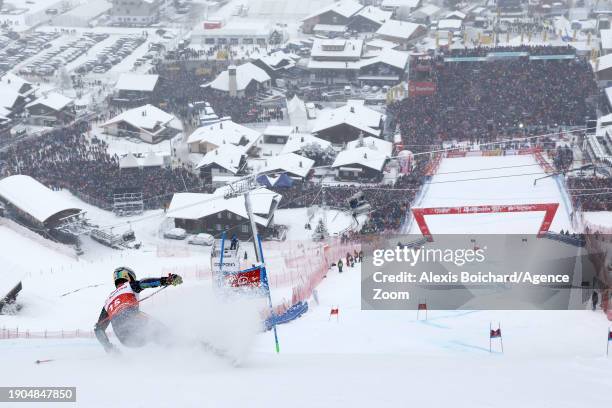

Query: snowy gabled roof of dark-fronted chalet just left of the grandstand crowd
[312,99,385,136]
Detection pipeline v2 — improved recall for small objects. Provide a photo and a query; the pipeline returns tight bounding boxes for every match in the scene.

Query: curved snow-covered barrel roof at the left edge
[0,174,82,223]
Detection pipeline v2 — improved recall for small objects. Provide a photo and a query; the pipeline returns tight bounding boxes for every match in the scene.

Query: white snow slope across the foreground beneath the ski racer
[0,252,612,408]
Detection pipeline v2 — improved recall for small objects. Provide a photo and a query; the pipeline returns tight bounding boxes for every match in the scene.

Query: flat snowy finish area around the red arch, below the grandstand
[409,155,573,234]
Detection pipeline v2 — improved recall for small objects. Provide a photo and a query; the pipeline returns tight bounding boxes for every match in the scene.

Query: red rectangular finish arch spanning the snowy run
[412,203,559,241]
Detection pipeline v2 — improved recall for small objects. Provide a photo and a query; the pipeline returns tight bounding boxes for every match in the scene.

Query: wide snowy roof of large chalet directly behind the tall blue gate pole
[166,188,282,227]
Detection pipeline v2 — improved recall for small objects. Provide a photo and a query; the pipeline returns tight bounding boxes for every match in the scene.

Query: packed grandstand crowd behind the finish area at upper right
[388,47,597,151]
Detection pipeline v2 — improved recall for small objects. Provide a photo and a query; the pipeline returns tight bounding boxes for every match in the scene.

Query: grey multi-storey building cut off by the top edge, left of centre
[110,0,166,26]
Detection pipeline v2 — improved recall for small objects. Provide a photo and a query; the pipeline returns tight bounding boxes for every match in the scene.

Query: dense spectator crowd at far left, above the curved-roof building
[0,123,201,209]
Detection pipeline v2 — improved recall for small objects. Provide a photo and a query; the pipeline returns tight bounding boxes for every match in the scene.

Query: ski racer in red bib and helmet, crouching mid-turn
[94,266,183,353]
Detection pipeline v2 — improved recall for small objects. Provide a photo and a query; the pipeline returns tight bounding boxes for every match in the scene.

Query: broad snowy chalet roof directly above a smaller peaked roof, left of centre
[187,119,261,149]
